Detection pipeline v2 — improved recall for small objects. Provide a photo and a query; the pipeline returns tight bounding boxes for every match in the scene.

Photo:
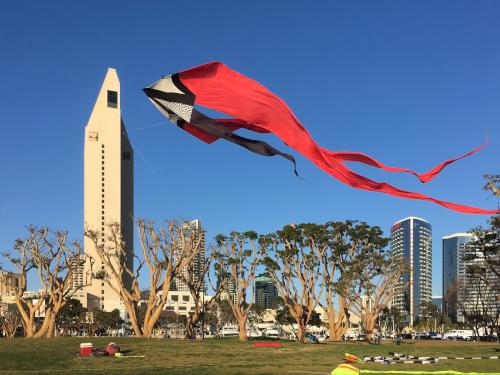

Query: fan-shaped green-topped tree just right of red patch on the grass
[261,224,327,342]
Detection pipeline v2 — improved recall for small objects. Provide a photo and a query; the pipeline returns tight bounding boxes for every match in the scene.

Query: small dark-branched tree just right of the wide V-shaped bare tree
[180,247,223,338]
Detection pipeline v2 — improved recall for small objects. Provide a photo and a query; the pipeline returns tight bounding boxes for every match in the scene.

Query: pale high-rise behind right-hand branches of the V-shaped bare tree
[171,219,205,292]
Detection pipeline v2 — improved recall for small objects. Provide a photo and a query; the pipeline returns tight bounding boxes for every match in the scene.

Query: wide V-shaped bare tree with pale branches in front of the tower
[85,219,201,337]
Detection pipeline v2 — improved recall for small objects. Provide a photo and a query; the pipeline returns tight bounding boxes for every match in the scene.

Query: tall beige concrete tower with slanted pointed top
[82,68,134,311]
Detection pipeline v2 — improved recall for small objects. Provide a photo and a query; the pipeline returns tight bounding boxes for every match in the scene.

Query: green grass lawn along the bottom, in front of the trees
[0,337,500,375]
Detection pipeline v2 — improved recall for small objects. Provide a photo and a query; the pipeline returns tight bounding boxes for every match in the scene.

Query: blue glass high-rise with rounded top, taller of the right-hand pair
[391,216,432,327]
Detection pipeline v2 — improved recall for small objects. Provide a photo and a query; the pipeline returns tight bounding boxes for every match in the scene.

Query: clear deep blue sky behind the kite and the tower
[0,0,500,294]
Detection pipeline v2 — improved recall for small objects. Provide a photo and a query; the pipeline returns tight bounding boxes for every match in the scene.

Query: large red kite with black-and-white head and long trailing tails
[144,62,500,214]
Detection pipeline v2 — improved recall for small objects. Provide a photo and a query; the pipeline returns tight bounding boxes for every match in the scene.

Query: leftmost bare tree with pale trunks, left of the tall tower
[4,226,90,337]
